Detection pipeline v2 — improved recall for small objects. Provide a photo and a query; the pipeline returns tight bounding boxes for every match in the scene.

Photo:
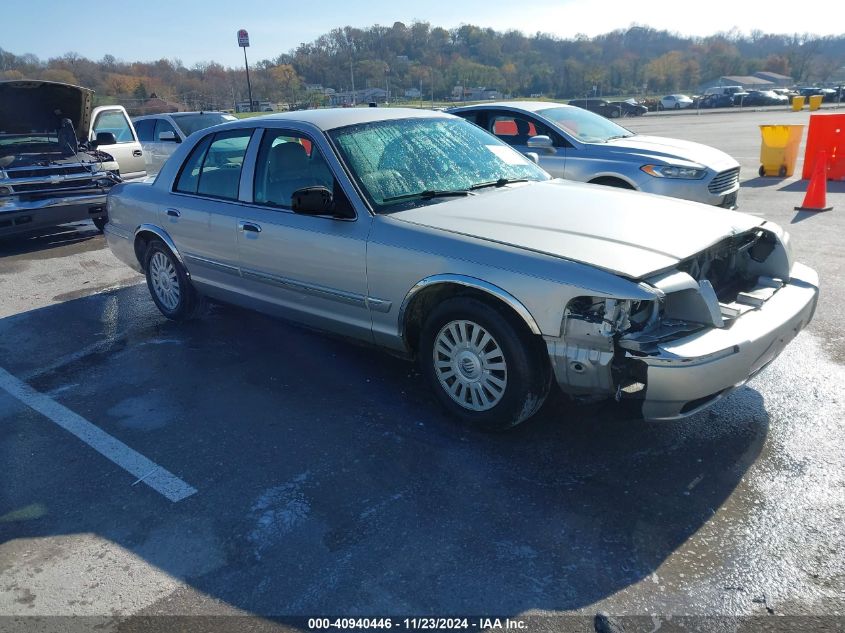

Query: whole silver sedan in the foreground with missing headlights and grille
[106,108,818,429]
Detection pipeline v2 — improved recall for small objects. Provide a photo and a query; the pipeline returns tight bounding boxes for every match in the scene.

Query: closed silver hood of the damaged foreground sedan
[390,180,763,279]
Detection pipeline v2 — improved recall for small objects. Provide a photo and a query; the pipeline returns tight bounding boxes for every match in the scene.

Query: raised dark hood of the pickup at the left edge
[0,79,94,140]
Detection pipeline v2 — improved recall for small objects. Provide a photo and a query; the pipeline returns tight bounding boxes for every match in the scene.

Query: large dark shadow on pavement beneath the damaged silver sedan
[0,286,769,616]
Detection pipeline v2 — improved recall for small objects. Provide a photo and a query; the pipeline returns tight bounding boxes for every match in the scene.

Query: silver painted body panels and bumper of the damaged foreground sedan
[106,109,818,419]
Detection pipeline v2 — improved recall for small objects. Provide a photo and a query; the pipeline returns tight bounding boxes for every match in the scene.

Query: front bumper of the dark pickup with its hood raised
[0,192,106,235]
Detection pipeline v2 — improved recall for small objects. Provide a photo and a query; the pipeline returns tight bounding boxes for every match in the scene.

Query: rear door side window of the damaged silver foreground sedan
[175,130,252,200]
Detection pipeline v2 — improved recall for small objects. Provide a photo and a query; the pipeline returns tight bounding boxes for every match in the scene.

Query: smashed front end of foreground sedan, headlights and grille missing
[546,223,818,420]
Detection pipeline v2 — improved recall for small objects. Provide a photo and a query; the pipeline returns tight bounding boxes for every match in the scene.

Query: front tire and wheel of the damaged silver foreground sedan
[419,297,551,432]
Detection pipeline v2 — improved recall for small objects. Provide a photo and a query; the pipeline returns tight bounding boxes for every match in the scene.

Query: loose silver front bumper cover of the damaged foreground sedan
[631,264,819,420]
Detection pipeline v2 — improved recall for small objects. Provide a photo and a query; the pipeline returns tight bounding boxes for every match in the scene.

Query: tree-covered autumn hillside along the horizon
[0,22,845,109]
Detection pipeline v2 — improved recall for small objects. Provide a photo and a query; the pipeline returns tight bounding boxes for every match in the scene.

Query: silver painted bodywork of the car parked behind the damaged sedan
[450,101,739,206]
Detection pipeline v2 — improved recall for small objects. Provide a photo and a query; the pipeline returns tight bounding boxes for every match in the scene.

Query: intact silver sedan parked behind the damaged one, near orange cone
[449,101,739,208]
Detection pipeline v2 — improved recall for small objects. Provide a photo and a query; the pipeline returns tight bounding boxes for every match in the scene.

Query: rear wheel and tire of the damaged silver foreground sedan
[144,239,205,321]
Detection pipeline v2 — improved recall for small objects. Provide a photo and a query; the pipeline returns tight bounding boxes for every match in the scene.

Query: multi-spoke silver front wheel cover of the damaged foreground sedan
[433,321,508,411]
